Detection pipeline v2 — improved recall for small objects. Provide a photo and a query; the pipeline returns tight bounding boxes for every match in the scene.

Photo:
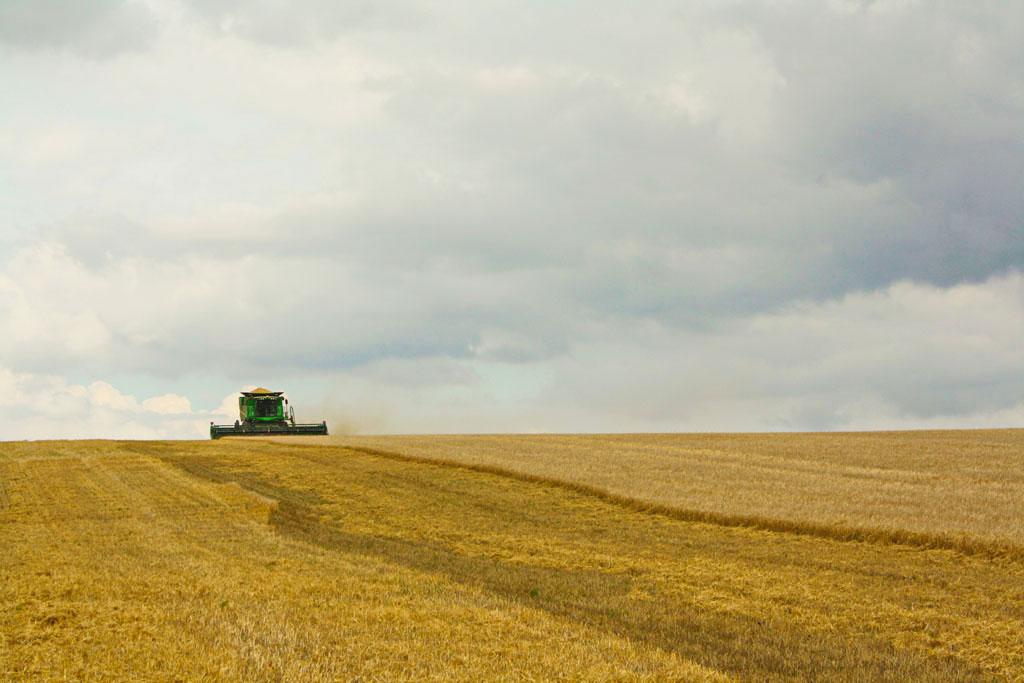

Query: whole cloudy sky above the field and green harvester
[0,0,1024,439]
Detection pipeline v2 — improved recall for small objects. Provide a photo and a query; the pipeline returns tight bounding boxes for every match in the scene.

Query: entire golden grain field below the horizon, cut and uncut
[0,432,1024,681]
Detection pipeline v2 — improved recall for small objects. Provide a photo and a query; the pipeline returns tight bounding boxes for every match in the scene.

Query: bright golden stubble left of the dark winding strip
[0,443,722,680]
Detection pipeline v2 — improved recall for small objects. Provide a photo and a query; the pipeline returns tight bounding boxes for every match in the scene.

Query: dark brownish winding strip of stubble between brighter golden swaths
[158,448,991,681]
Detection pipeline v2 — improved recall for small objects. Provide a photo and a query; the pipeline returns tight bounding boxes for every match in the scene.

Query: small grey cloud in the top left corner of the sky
[0,0,158,58]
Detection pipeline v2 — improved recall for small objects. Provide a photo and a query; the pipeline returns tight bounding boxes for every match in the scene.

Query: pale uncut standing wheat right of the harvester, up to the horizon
[329,429,1024,558]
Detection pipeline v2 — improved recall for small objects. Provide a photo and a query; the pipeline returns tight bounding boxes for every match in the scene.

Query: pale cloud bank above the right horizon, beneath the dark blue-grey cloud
[550,271,1024,430]
